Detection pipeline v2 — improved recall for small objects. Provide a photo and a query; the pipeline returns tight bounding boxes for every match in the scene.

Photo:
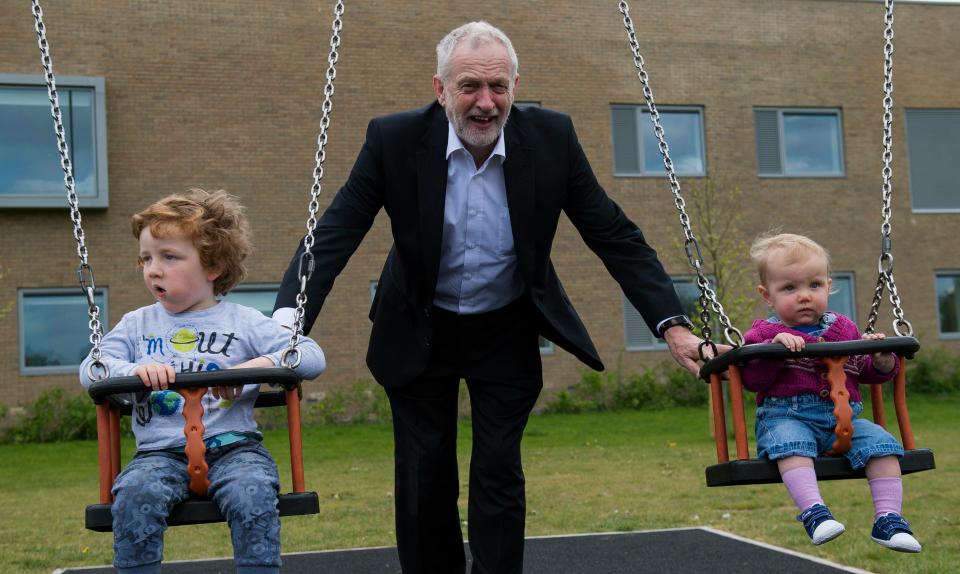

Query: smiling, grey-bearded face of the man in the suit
[433,41,519,152]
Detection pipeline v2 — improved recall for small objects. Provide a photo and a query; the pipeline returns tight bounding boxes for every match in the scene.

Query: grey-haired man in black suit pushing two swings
[274,22,700,574]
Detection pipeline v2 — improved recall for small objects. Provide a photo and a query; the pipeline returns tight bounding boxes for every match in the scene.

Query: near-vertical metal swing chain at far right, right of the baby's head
[864,0,913,337]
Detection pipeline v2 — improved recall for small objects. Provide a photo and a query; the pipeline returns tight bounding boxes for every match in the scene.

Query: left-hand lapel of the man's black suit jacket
[417,103,447,300]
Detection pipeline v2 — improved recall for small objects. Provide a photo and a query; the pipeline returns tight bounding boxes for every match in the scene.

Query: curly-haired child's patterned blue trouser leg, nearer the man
[208,440,280,574]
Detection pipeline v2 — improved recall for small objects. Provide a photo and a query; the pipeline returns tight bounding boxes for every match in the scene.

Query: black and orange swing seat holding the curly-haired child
[85,368,320,532]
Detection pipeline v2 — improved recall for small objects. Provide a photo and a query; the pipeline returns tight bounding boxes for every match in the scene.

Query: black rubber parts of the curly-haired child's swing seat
[85,368,320,532]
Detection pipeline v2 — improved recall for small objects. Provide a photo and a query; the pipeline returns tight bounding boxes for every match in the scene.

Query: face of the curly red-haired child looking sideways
[140,227,220,313]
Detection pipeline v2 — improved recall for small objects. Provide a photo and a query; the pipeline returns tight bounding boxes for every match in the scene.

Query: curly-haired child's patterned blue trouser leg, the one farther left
[112,453,189,574]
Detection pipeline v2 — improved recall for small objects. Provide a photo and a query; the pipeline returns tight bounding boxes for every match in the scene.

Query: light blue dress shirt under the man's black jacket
[433,124,523,314]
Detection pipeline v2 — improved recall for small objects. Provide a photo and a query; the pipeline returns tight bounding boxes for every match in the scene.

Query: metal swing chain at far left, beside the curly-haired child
[32,0,110,388]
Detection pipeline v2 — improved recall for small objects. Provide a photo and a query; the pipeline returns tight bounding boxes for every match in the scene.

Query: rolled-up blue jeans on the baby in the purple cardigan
[756,394,903,468]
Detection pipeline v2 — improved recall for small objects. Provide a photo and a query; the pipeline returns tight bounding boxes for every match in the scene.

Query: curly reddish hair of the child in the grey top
[131,188,253,295]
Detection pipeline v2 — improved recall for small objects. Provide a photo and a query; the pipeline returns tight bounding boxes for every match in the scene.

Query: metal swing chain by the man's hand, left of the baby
[619,0,743,360]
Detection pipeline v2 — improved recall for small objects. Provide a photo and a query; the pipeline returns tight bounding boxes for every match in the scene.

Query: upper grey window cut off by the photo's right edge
[906,110,960,212]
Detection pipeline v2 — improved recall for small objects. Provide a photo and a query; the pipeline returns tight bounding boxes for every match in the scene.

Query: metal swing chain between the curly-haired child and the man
[280,0,343,369]
